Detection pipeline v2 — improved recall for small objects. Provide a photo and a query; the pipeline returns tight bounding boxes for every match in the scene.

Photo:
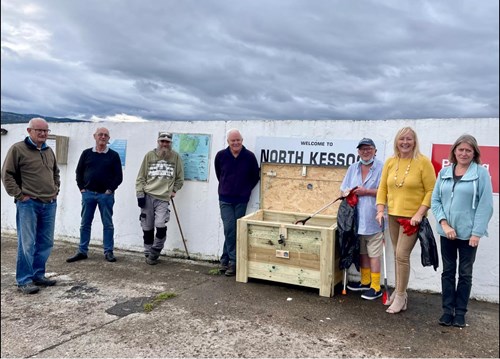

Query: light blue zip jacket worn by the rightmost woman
[431,162,493,240]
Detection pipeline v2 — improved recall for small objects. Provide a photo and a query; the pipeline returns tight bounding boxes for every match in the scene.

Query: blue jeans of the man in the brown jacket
[16,199,57,285]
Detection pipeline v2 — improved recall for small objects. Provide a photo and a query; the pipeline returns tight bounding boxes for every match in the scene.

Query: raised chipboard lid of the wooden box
[260,163,347,215]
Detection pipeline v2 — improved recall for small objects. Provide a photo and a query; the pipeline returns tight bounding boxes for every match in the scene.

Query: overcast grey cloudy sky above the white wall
[1,0,499,120]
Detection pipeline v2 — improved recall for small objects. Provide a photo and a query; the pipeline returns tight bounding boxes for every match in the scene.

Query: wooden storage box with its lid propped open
[236,163,347,297]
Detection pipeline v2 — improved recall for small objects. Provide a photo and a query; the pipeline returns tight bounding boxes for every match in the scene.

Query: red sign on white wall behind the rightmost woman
[431,144,499,193]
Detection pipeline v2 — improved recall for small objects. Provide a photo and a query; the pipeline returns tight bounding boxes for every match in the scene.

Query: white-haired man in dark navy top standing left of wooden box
[215,129,260,276]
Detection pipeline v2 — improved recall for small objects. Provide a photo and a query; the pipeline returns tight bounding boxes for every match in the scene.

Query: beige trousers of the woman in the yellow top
[389,216,418,294]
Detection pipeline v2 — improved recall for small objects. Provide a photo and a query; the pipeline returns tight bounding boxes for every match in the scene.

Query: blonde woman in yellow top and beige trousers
[376,127,436,314]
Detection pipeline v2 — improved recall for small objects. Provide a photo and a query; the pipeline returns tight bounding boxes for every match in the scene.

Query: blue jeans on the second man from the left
[78,191,115,254]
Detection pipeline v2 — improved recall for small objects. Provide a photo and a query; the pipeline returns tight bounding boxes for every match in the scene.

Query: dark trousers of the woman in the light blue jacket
[441,236,477,315]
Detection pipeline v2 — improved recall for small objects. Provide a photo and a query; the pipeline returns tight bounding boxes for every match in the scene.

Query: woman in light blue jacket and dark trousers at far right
[431,134,493,327]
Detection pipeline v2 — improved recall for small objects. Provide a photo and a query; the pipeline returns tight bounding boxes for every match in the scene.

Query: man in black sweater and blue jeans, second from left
[66,127,123,263]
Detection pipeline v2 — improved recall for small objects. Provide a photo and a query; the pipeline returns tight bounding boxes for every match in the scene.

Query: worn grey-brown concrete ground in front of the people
[1,235,499,358]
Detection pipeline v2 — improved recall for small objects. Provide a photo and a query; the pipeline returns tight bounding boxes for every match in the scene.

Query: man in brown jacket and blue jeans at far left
[2,117,60,294]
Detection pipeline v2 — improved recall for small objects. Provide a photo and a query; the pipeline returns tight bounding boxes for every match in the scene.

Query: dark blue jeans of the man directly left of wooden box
[219,201,247,265]
